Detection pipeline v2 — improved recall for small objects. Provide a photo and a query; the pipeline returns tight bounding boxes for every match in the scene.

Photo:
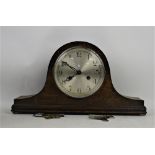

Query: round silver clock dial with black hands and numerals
[54,46,105,98]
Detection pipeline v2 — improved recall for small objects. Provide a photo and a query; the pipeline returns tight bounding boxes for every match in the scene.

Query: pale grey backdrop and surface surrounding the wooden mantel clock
[1,27,153,127]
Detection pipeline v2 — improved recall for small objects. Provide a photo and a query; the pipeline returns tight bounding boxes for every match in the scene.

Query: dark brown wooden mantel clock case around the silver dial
[12,41,146,115]
